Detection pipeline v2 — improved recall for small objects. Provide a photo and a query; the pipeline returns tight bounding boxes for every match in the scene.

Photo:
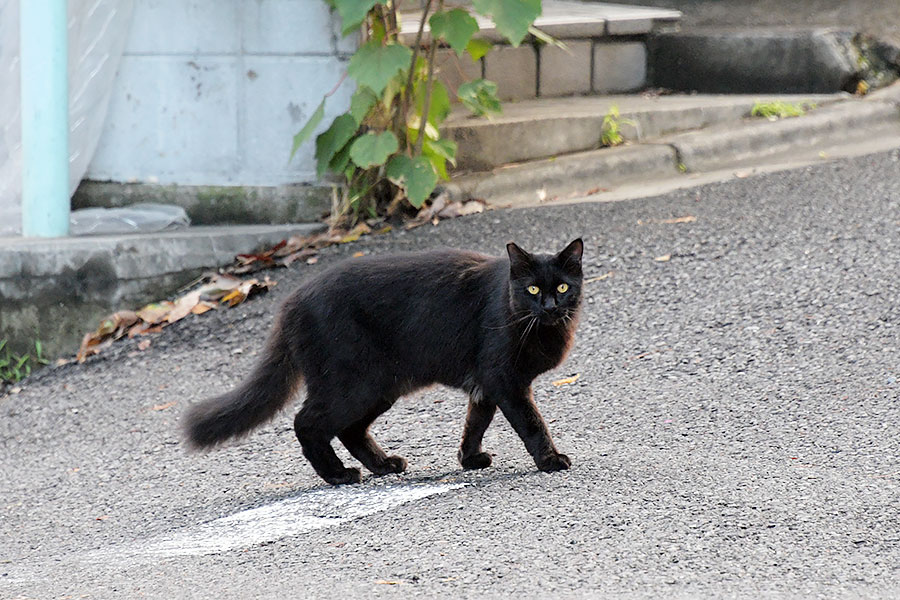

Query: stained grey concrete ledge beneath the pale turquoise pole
[0,223,324,356]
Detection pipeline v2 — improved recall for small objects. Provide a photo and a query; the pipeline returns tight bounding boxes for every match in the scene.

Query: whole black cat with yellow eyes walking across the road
[186,239,584,484]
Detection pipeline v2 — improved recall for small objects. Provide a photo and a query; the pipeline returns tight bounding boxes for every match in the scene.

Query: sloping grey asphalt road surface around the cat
[0,151,900,599]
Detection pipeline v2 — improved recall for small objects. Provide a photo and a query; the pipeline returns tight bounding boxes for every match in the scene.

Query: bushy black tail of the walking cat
[184,325,302,448]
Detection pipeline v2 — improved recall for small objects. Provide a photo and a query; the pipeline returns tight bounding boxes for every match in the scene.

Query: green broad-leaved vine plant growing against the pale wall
[291,0,541,226]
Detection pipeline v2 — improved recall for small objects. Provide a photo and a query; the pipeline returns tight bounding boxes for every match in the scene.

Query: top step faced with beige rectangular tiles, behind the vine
[400,0,681,100]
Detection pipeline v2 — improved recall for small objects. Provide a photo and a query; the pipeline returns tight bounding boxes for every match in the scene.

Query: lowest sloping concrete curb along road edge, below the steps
[444,90,900,206]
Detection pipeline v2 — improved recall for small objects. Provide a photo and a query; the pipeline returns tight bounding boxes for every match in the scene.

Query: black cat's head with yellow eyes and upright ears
[506,238,584,324]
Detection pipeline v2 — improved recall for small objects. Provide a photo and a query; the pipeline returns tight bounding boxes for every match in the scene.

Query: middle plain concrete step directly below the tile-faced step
[442,94,848,172]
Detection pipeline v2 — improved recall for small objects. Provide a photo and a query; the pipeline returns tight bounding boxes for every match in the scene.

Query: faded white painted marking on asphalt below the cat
[92,483,466,560]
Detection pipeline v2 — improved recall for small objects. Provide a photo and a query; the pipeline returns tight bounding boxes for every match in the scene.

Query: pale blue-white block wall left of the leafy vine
[86,0,356,186]
